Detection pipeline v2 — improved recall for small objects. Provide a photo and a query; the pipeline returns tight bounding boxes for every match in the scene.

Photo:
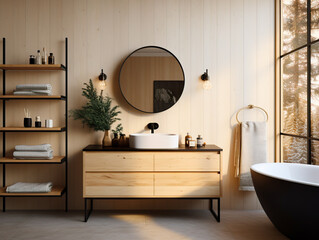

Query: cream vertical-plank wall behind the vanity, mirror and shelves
[0,0,275,209]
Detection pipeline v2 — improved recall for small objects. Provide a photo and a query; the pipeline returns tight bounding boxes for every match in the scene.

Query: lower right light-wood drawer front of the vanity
[154,172,220,197]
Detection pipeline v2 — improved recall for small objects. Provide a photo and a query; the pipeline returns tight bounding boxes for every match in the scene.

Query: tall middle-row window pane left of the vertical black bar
[281,48,307,136]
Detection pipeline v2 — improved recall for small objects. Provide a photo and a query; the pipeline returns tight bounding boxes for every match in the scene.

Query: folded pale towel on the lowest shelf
[6,182,52,193]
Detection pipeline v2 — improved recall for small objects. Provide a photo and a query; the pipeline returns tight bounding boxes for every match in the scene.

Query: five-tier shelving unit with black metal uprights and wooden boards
[0,38,68,212]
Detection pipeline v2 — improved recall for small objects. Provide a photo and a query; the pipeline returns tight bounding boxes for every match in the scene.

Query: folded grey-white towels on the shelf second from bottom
[13,144,53,159]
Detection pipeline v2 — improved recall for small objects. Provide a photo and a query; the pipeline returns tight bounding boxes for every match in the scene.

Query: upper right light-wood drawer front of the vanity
[154,152,220,171]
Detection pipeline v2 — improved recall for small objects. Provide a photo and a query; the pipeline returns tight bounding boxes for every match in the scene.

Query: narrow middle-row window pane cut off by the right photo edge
[311,43,319,138]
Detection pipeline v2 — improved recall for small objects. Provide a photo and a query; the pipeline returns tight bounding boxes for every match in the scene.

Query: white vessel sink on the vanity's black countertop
[130,133,178,149]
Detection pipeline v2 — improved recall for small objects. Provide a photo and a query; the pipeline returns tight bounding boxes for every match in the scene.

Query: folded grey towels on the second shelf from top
[13,84,52,96]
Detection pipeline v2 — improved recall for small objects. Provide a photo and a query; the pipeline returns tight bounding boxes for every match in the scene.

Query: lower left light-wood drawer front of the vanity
[83,173,154,197]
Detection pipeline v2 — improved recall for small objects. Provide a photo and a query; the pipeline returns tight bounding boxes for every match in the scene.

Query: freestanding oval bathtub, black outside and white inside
[250,163,319,239]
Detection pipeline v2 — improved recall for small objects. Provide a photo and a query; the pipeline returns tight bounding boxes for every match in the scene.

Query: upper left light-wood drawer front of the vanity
[83,152,153,172]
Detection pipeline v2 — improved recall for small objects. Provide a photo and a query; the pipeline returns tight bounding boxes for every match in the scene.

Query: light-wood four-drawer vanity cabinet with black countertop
[83,145,222,220]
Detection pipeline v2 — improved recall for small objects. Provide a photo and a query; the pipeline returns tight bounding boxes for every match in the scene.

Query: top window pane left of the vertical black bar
[281,0,307,54]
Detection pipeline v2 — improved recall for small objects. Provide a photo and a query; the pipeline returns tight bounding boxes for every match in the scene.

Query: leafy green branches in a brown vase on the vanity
[70,79,121,146]
